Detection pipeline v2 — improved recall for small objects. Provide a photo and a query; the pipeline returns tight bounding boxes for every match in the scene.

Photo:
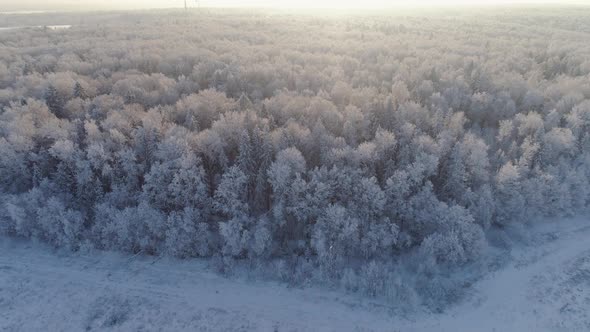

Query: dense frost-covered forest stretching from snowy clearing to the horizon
[0,8,590,304]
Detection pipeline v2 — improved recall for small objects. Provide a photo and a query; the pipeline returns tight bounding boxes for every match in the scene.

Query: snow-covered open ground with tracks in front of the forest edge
[0,219,590,332]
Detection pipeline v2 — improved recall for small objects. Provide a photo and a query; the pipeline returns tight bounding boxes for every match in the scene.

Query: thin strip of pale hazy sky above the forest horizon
[0,0,590,12]
